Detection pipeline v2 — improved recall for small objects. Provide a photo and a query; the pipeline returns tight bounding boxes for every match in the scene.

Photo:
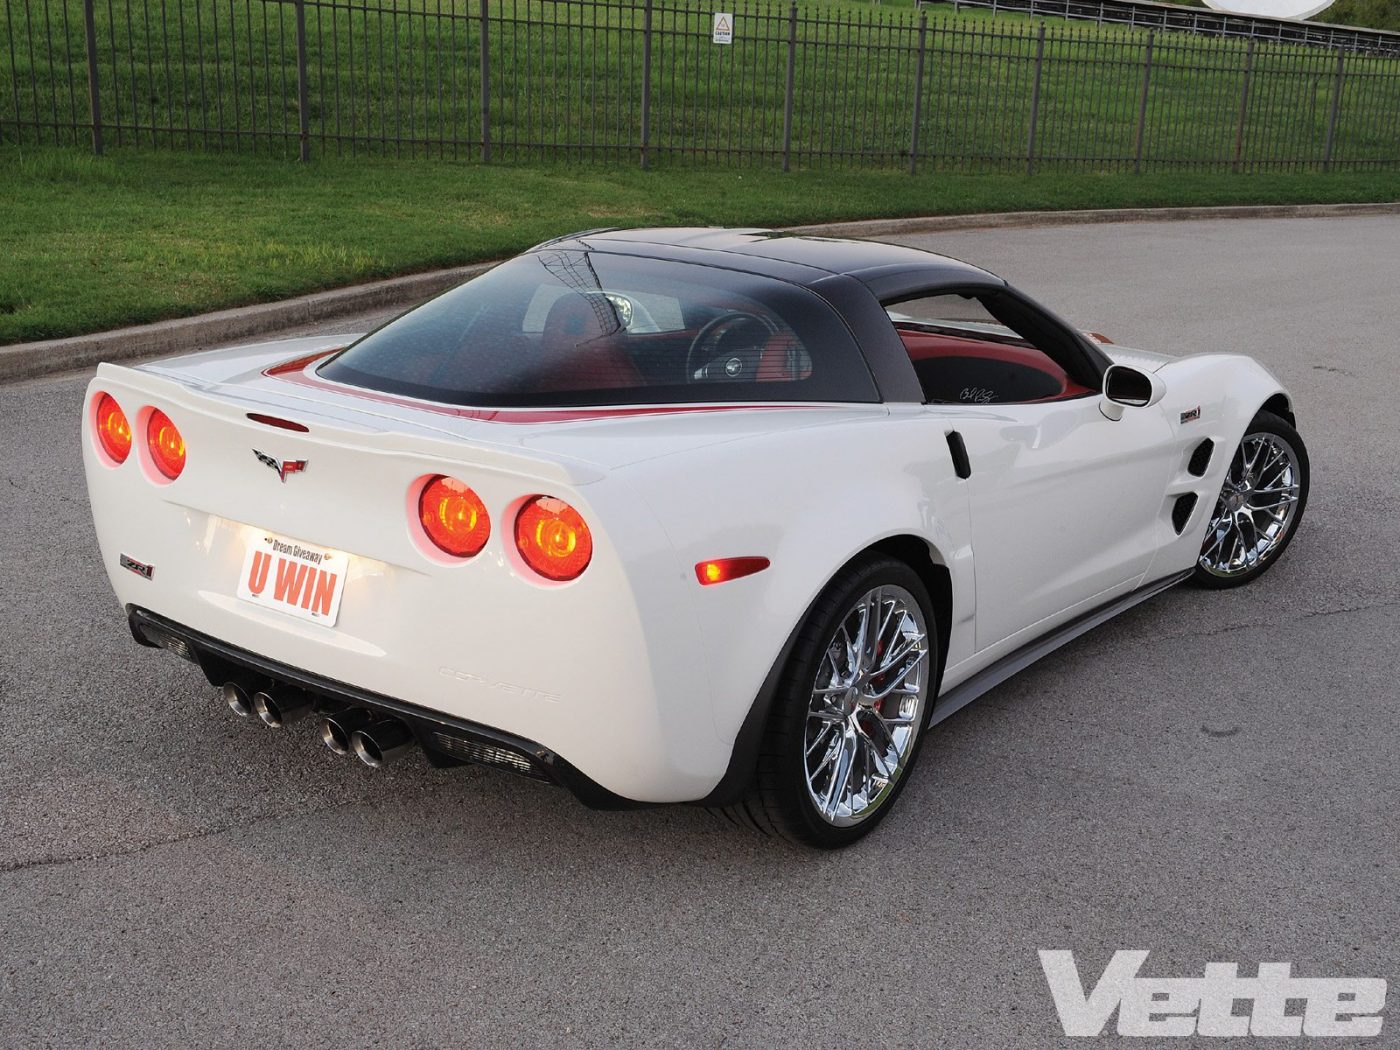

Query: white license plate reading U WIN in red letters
[238,535,350,627]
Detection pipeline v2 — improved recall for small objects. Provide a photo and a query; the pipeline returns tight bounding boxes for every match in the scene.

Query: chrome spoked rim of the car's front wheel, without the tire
[1198,431,1302,580]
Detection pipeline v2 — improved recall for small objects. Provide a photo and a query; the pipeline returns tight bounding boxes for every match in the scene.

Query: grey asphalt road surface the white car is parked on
[0,218,1400,1050]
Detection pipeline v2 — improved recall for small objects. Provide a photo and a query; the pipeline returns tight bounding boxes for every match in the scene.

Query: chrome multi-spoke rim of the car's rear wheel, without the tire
[804,585,931,827]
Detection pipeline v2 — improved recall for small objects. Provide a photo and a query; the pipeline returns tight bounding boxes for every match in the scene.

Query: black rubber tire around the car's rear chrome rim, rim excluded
[721,554,938,850]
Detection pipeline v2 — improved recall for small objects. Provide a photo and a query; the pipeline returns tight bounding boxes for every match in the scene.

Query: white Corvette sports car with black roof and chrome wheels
[83,230,1308,847]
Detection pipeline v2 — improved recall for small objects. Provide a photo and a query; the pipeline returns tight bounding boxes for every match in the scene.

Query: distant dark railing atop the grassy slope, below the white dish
[921,0,1400,55]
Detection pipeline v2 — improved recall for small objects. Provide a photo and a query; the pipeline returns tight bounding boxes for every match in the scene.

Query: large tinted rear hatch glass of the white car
[319,249,879,407]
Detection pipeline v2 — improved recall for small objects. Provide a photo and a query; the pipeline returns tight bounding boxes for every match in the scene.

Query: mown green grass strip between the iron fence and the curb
[0,147,1400,343]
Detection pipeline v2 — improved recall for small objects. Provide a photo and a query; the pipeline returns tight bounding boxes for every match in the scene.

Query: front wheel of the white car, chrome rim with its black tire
[1191,412,1309,588]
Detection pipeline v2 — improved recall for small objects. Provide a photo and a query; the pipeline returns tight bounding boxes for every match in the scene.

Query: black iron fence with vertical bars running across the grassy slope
[0,0,1400,172]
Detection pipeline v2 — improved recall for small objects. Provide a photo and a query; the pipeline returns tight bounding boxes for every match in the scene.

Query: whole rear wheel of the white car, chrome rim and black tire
[724,554,938,850]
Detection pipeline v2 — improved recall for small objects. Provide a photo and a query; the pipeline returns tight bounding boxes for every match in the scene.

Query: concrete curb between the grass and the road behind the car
[0,202,1400,382]
